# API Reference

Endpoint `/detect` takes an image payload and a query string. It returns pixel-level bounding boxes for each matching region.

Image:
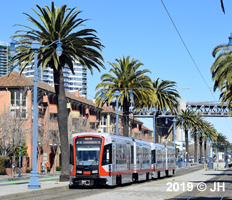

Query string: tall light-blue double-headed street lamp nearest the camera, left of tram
[9,39,63,189]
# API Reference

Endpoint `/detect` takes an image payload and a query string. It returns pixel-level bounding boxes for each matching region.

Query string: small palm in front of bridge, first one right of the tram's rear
[176,109,195,160]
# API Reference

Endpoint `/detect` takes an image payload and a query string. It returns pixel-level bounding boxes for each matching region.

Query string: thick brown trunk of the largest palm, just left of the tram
[53,66,69,181]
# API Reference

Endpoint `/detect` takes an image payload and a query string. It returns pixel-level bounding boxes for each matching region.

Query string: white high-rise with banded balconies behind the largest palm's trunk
[22,62,87,96]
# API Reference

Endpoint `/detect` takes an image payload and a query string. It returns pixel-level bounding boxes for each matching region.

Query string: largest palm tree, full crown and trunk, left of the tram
[10,2,104,181]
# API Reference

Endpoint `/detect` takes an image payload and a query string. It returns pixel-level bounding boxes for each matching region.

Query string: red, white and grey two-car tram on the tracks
[69,132,175,188]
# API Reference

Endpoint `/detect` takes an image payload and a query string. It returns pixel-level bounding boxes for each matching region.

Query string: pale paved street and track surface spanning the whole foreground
[0,165,232,200]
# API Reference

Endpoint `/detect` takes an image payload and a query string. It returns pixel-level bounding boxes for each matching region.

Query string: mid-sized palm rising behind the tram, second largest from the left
[95,56,153,136]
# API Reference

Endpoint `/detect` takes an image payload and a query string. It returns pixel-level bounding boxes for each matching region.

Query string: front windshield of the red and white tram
[76,145,101,166]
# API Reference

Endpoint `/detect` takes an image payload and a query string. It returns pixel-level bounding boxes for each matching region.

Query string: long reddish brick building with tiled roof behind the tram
[0,72,152,173]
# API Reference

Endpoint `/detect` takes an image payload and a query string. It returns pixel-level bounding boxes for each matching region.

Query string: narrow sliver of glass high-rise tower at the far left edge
[0,41,9,77]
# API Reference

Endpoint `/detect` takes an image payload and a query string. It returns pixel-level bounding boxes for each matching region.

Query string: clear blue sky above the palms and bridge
[0,0,232,142]
